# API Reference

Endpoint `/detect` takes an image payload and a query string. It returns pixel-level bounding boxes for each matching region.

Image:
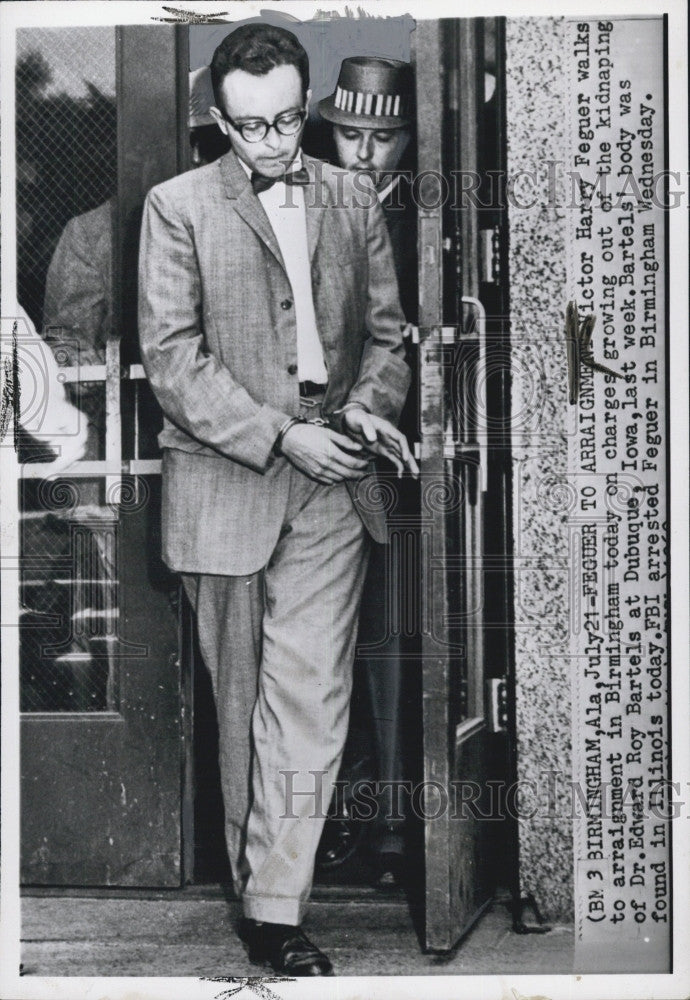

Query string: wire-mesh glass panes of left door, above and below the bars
[16,27,118,712]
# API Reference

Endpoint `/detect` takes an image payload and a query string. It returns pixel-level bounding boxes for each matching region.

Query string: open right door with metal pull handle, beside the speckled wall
[416,18,517,952]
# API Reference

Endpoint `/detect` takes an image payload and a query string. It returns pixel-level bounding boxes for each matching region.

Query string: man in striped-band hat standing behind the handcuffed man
[317,56,420,886]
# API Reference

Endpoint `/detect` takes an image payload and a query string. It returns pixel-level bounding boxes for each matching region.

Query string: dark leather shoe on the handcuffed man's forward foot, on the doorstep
[237,917,333,976]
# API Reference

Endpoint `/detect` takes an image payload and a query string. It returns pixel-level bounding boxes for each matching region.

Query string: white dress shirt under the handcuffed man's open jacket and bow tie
[238,157,328,385]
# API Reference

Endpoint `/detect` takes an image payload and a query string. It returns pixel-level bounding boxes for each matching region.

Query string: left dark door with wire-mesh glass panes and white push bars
[17,27,183,886]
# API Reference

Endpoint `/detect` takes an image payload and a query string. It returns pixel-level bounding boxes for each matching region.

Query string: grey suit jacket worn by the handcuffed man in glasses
[139,152,410,575]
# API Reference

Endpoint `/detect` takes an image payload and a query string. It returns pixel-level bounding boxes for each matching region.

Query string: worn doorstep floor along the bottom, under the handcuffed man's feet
[21,886,574,977]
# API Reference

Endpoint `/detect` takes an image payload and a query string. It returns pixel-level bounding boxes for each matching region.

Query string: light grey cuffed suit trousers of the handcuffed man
[183,414,369,924]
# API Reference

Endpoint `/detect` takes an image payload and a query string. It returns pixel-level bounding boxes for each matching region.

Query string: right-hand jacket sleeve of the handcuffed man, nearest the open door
[341,186,411,424]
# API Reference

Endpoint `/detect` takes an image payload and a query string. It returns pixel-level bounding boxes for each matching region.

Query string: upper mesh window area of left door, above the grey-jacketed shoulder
[16,28,117,328]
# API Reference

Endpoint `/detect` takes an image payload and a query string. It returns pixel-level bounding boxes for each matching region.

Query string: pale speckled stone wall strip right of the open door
[506,18,573,921]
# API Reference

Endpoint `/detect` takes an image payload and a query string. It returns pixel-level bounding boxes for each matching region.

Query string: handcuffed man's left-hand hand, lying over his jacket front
[280,424,369,483]
